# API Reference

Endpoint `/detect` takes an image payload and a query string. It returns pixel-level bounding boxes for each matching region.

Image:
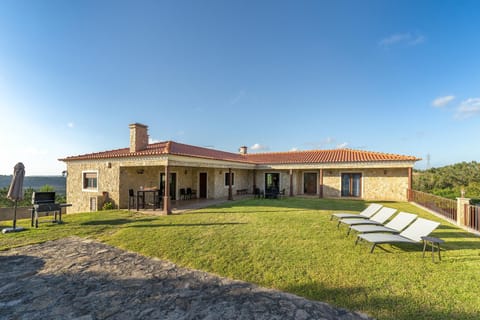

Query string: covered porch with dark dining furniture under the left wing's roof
[118,159,253,214]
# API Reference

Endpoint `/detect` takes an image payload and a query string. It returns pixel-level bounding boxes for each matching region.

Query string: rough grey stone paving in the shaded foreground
[0,237,369,320]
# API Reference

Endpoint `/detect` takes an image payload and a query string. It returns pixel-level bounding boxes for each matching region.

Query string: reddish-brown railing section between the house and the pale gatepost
[408,189,458,221]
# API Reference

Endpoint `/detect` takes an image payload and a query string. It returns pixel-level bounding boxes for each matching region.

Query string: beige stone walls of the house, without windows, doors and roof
[67,158,408,212]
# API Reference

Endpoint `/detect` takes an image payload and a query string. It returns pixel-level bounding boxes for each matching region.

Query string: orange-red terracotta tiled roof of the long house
[60,141,420,164]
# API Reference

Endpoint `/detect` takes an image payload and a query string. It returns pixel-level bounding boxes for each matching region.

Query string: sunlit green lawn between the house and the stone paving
[0,198,480,319]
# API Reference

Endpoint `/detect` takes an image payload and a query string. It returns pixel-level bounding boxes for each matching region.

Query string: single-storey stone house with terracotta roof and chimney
[60,123,420,214]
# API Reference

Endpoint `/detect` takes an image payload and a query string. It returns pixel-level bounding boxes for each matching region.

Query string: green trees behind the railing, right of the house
[412,161,480,202]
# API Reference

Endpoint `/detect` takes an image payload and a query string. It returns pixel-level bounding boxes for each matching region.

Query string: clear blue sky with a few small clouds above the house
[0,0,480,175]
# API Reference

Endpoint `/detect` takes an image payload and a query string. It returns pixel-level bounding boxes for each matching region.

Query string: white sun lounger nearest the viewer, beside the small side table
[356,218,440,253]
